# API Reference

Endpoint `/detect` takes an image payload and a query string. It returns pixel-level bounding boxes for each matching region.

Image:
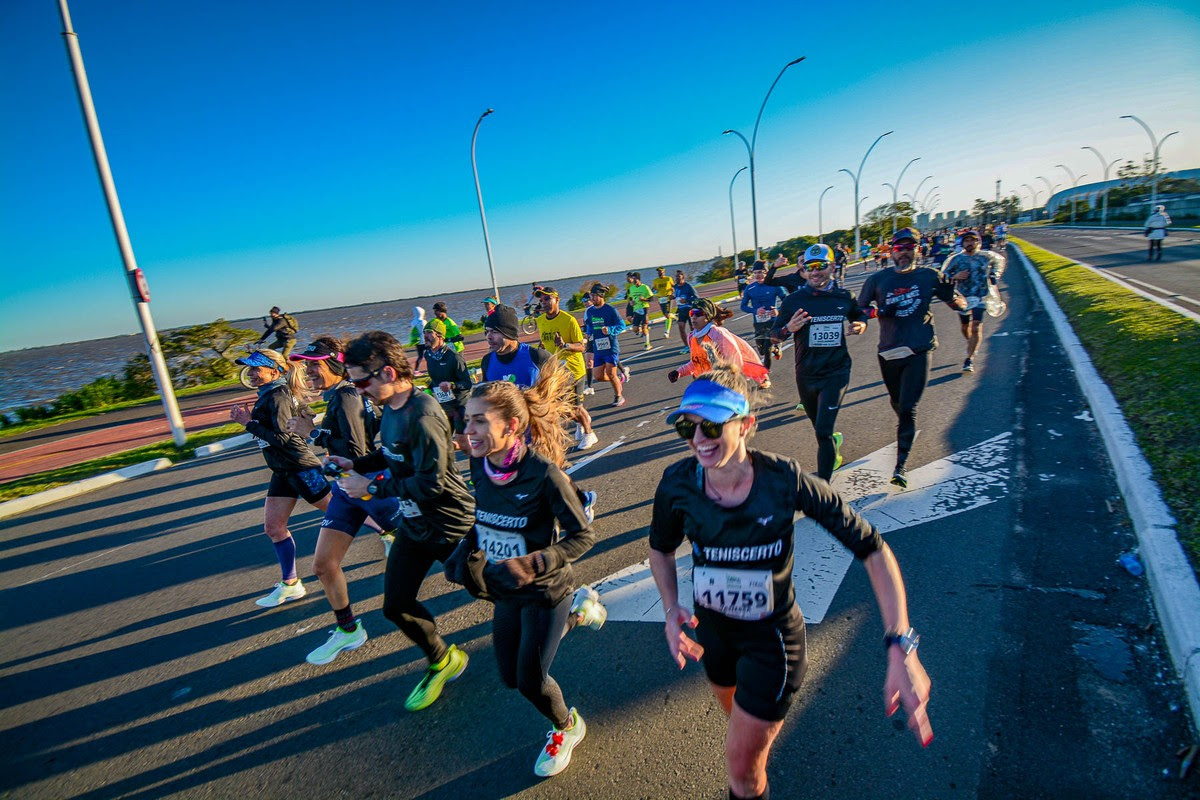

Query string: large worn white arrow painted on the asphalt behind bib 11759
[594,432,1012,625]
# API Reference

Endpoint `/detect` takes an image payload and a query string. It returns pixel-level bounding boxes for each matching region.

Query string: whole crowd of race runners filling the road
[232,228,1003,798]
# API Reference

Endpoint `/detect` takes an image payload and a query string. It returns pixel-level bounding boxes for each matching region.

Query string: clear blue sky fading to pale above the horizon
[0,0,1200,349]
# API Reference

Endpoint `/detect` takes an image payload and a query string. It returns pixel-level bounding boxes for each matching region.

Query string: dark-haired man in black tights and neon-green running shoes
[328,331,477,711]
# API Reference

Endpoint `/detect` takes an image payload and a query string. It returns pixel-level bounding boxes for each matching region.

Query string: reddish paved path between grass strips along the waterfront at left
[0,279,733,483]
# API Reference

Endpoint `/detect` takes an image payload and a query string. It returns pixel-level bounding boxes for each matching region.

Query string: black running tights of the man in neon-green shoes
[383,533,455,663]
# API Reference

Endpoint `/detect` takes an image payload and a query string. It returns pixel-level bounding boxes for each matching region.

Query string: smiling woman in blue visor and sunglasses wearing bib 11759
[649,366,934,798]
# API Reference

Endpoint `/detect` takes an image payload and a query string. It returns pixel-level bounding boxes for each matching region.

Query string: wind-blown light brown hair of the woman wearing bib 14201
[470,359,575,467]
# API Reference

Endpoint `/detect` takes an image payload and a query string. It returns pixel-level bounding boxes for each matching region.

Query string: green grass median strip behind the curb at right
[1010,237,1200,573]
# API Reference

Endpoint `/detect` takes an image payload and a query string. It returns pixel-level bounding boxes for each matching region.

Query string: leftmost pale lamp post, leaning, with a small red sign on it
[59,0,187,447]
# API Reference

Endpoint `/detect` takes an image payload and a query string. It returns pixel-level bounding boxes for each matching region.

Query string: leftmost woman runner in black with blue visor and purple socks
[229,350,329,608]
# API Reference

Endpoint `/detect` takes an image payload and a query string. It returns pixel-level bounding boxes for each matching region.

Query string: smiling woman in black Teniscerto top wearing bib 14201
[446,369,607,777]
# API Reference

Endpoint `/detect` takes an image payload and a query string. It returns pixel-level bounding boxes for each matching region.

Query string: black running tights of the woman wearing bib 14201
[492,595,571,729]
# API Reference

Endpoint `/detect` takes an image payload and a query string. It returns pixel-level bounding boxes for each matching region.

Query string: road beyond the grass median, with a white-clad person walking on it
[1013,227,1200,312]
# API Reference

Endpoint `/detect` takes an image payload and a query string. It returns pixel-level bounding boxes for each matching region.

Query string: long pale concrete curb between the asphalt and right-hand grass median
[1013,239,1200,727]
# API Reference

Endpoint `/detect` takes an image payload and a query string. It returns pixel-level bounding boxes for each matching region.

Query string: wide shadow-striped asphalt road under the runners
[0,257,1200,800]
